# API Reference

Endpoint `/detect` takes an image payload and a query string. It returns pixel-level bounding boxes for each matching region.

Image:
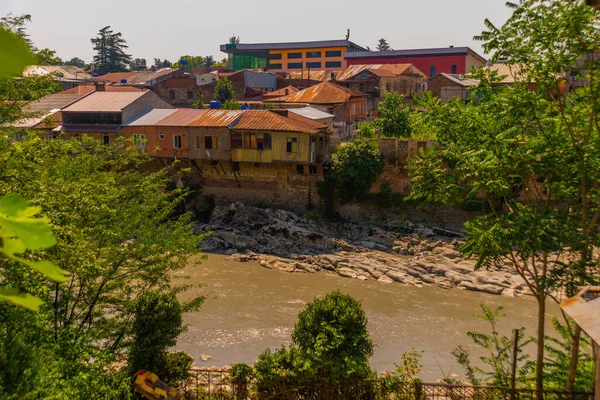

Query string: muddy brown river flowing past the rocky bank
[176,254,558,381]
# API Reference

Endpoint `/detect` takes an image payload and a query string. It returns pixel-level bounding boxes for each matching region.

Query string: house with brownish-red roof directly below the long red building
[336,64,427,111]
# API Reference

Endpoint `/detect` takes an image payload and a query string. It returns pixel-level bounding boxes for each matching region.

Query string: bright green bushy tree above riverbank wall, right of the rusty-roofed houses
[375,91,411,138]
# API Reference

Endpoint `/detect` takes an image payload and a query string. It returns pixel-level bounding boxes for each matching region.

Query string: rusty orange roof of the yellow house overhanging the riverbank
[234,110,327,133]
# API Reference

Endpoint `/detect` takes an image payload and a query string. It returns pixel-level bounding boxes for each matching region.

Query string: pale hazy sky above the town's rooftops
[0,0,510,64]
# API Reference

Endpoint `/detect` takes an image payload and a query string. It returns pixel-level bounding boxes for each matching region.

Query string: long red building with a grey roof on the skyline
[346,46,486,77]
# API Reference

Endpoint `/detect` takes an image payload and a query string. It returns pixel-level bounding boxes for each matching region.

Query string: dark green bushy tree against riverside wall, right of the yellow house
[326,139,383,203]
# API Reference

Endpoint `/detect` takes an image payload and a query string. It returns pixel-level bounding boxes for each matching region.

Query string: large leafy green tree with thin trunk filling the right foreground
[410,0,600,392]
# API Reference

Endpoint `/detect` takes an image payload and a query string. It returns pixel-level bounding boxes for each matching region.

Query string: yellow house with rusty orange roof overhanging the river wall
[231,110,329,169]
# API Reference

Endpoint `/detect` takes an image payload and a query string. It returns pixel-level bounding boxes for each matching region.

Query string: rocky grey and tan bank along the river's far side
[196,203,529,297]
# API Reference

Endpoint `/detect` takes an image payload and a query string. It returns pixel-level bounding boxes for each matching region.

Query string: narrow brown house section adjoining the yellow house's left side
[188,110,245,163]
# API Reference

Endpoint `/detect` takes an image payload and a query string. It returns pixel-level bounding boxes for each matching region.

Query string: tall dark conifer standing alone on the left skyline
[90,26,132,75]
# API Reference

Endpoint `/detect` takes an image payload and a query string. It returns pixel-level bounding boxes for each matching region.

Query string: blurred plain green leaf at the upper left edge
[0,28,35,78]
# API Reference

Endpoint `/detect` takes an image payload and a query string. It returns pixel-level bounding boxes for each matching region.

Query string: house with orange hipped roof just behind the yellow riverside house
[285,82,369,137]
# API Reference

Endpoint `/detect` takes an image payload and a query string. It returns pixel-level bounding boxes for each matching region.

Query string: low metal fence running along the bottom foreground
[180,368,594,400]
